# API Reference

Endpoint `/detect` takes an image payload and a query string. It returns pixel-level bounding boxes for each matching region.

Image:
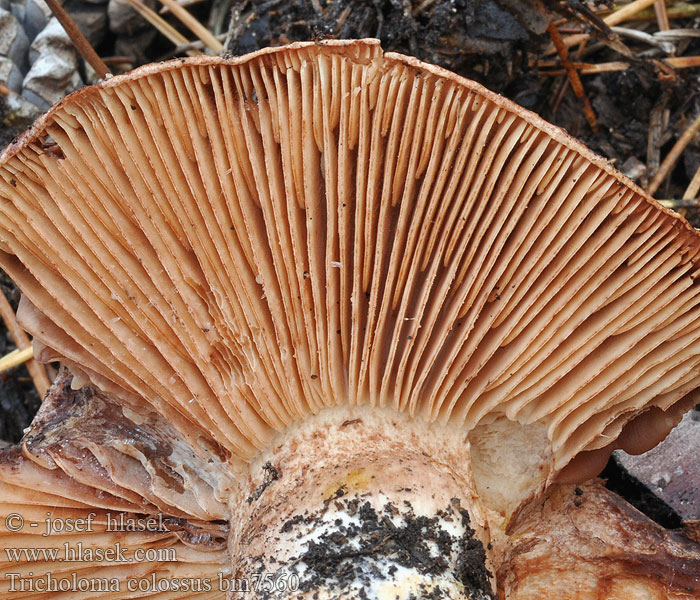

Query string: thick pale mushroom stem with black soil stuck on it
[229,406,493,599]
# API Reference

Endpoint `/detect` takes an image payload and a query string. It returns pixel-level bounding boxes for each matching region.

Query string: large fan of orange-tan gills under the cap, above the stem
[0,40,700,478]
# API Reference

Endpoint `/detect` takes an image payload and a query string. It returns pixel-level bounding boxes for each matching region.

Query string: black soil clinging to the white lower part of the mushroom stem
[274,488,493,600]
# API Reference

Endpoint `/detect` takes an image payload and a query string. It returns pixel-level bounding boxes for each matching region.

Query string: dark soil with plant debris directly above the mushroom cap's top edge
[227,0,549,92]
